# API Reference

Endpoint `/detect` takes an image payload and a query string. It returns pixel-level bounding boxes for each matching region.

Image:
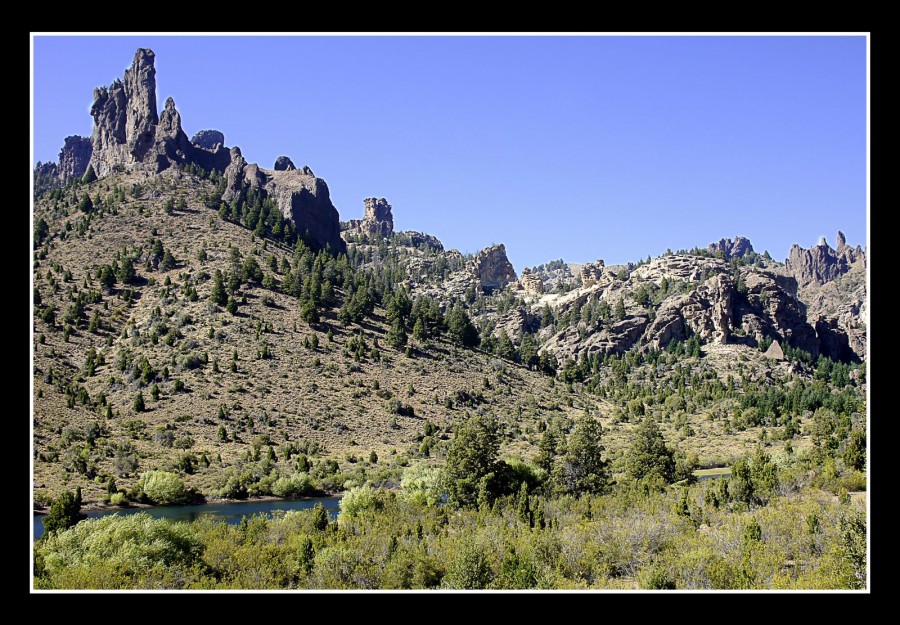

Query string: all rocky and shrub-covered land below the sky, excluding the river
[32,49,867,590]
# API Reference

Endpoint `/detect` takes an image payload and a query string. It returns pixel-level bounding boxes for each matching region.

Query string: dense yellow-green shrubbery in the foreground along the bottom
[36,456,865,589]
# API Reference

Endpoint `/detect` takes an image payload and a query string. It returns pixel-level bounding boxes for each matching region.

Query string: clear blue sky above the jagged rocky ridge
[33,36,866,271]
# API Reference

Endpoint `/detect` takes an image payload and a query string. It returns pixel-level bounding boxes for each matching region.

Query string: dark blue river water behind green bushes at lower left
[33,497,340,540]
